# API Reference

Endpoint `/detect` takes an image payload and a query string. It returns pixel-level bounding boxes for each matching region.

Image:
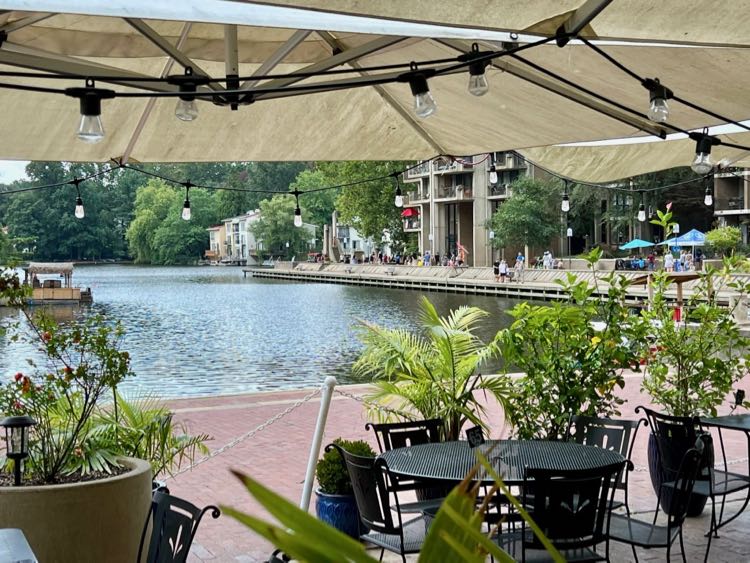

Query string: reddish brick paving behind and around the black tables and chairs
[167,373,750,563]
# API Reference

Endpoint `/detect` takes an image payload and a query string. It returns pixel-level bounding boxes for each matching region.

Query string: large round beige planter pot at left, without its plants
[0,458,151,563]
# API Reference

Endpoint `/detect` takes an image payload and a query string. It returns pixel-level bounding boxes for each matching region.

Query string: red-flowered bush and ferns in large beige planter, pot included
[0,272,209,562]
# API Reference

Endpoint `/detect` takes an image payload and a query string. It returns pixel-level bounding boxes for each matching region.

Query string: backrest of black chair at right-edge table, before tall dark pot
[635,406,714,481]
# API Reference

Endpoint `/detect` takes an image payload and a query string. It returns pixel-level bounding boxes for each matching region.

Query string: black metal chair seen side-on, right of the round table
[609,446,711,563]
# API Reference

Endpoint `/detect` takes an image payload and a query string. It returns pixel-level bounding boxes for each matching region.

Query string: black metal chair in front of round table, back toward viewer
[498,461,627,562]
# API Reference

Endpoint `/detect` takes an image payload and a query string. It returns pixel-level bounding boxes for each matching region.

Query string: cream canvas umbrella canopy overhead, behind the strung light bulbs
[0,0,750,180]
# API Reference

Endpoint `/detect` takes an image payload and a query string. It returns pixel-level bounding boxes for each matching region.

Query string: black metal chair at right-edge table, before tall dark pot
[635,406,750,558]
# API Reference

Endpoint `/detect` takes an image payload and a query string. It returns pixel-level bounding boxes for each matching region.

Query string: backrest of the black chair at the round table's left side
[326,444,401,534]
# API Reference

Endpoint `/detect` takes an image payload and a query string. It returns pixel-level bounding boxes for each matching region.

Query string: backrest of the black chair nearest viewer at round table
[523,461,627,550]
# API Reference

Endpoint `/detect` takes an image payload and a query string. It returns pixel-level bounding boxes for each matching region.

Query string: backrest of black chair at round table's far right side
[567,415,645,490]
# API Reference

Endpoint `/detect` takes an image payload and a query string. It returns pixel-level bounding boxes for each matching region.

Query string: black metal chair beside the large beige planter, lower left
[138,491,221,563]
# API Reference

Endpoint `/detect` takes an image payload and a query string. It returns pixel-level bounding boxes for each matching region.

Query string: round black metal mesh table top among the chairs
[380,440,625,484]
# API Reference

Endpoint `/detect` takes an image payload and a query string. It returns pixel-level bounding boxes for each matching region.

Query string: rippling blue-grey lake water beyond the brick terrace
[0,265,517,397]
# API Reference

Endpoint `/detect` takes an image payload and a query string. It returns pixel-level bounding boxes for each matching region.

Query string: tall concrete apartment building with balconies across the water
[401,152,540,266]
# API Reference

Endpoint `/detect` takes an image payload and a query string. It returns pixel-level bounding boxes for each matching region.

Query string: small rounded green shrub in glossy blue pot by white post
[315,438,375,538]
